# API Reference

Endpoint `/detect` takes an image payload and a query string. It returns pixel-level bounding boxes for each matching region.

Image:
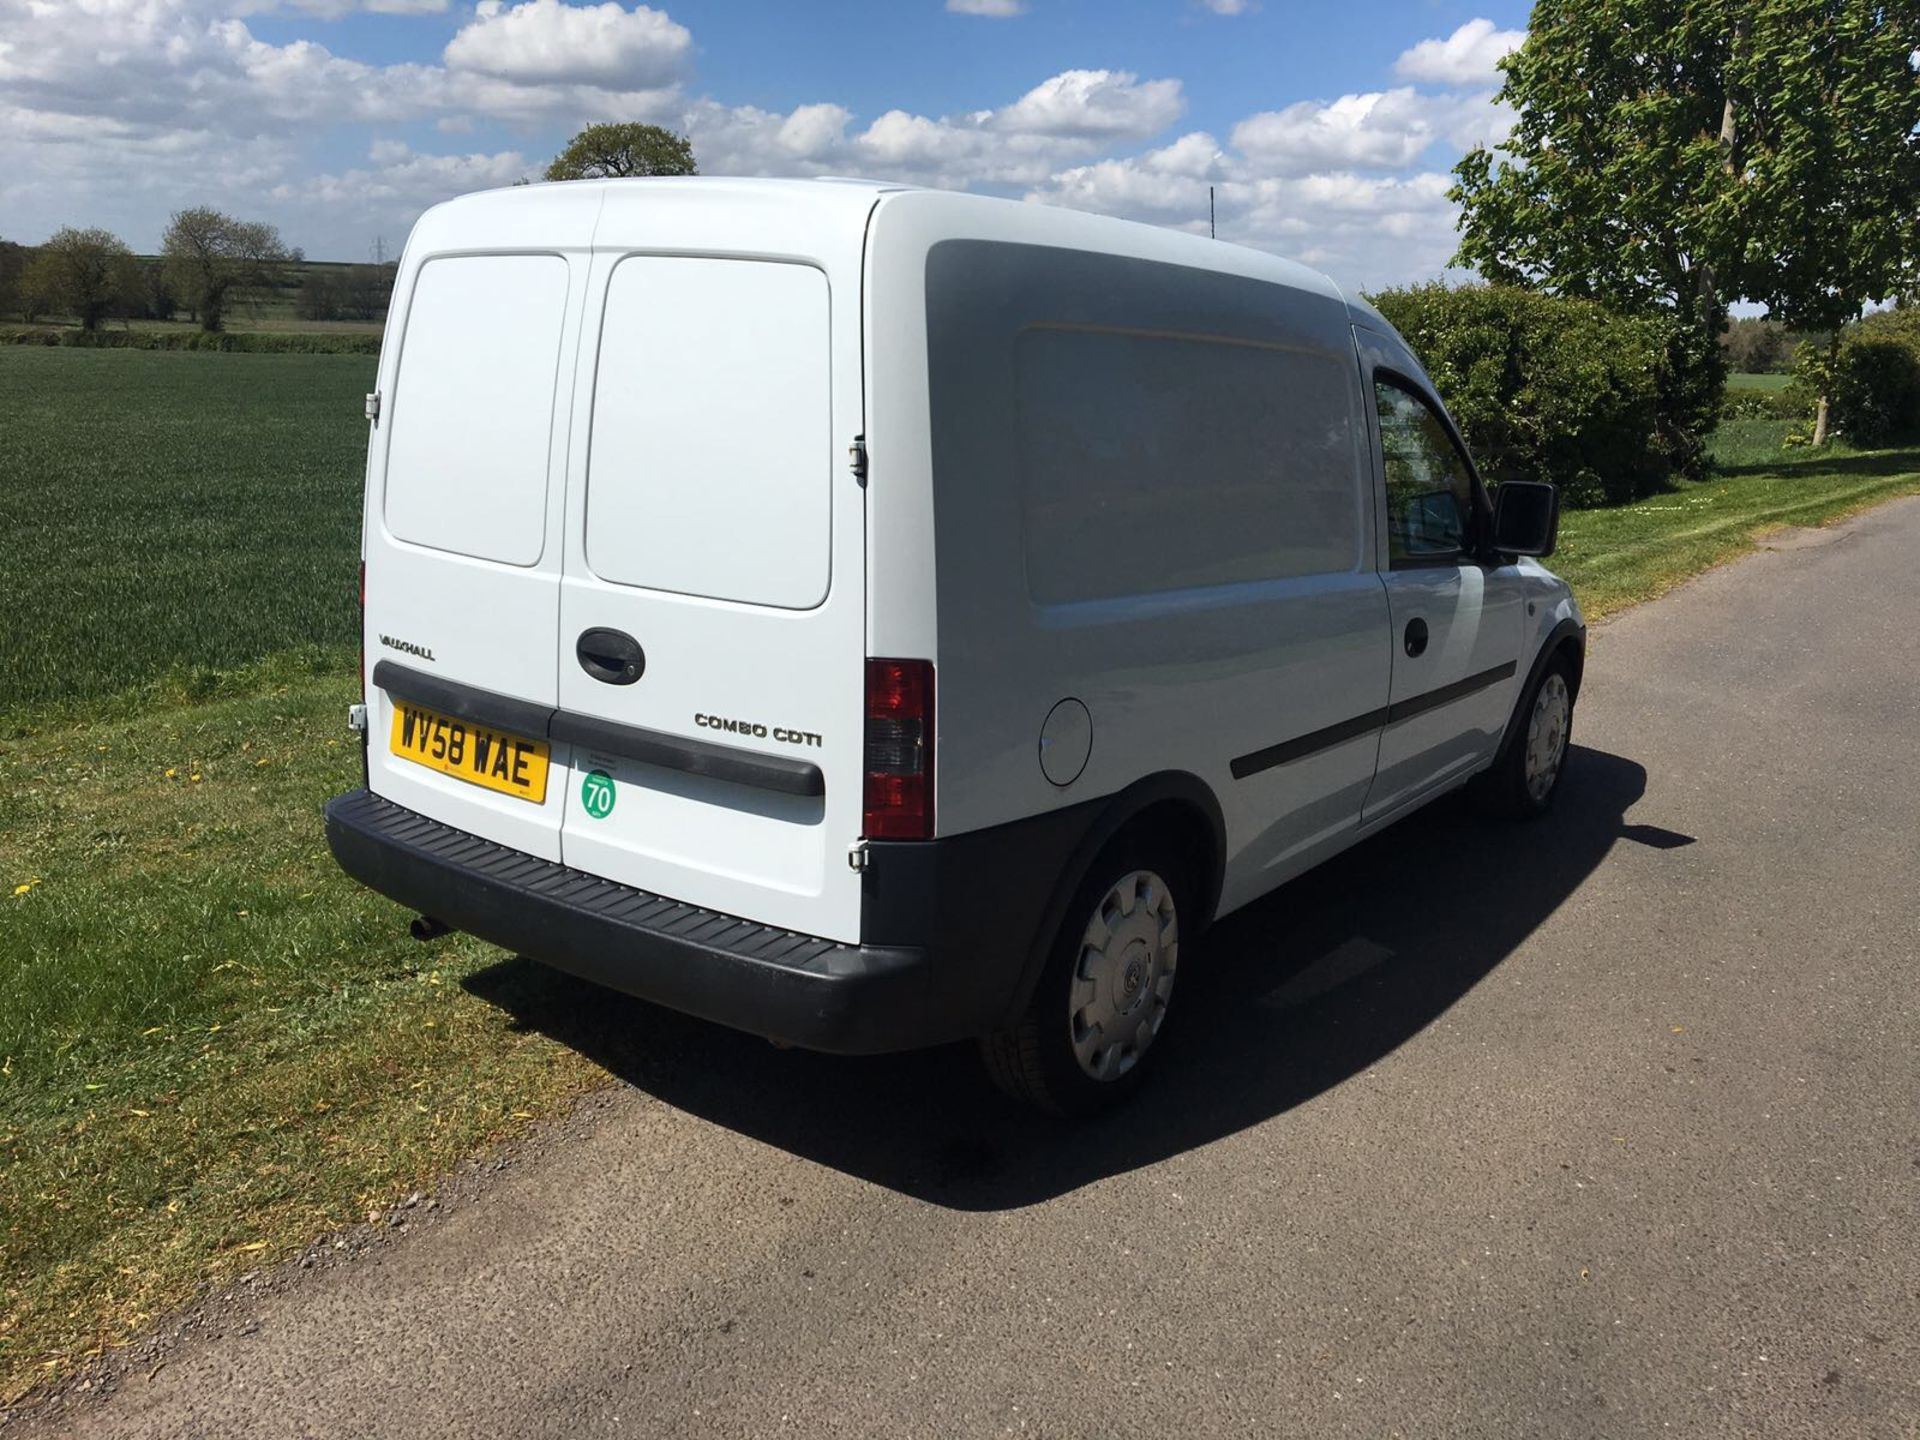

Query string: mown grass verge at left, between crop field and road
[0,674,599,1404]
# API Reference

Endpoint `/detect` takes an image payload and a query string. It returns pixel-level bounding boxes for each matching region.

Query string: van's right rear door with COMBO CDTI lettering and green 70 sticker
[555,184,870,941]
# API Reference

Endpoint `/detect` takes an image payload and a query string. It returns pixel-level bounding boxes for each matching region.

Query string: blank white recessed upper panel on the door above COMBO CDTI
[586,255,833,611]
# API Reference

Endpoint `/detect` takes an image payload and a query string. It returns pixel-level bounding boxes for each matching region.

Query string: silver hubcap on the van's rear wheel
[1068,870,1181,1081]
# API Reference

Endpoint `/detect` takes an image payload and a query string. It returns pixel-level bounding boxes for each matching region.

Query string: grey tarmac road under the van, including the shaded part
[25,499,1920,1440]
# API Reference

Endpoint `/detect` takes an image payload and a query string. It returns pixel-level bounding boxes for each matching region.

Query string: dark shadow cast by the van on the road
[467,747,1666,1210]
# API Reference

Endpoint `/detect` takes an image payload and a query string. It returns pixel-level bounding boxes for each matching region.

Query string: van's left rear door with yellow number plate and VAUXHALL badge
[363,188,599,860]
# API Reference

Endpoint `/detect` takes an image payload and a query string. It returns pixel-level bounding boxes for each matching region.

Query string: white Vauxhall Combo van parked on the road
[326,179,1586,1112]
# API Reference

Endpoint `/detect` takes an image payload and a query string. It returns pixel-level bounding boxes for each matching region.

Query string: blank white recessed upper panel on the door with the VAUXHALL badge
[382,255,566,564]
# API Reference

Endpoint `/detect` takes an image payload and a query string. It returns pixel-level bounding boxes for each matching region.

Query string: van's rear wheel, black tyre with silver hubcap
[981,837,1194,1117]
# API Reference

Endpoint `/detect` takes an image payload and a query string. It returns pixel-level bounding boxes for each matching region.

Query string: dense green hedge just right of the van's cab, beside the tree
[1369,282,1697,505]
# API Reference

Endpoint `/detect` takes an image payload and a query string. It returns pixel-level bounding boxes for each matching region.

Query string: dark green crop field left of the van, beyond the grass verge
[0,348,374,733]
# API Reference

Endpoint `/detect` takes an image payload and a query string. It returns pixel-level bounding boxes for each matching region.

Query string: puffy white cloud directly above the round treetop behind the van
[445,0,693,90]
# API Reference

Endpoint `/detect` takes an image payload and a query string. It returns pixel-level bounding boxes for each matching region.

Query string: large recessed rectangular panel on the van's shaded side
[1014,323,1361,605]
